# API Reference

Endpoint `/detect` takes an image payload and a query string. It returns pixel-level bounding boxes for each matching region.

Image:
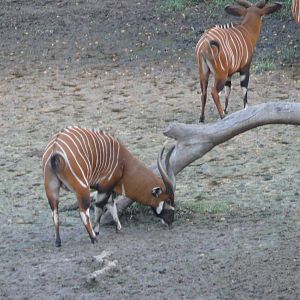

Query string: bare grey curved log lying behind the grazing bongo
[101,102,300,225]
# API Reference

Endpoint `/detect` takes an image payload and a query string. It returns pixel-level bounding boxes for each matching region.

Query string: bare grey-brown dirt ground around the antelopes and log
[0,0,300,299]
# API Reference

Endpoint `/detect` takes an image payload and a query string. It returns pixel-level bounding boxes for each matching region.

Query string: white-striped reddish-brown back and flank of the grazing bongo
[42,127,120,188]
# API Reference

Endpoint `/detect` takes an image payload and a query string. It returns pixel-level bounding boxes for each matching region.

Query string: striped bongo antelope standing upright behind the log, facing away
[195,0,281,122]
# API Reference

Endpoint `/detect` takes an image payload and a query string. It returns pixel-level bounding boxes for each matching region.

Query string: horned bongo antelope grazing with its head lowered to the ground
[42,127,175,247]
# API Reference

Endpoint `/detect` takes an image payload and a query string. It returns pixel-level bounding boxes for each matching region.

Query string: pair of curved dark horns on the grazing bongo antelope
[157,146,175,198]
